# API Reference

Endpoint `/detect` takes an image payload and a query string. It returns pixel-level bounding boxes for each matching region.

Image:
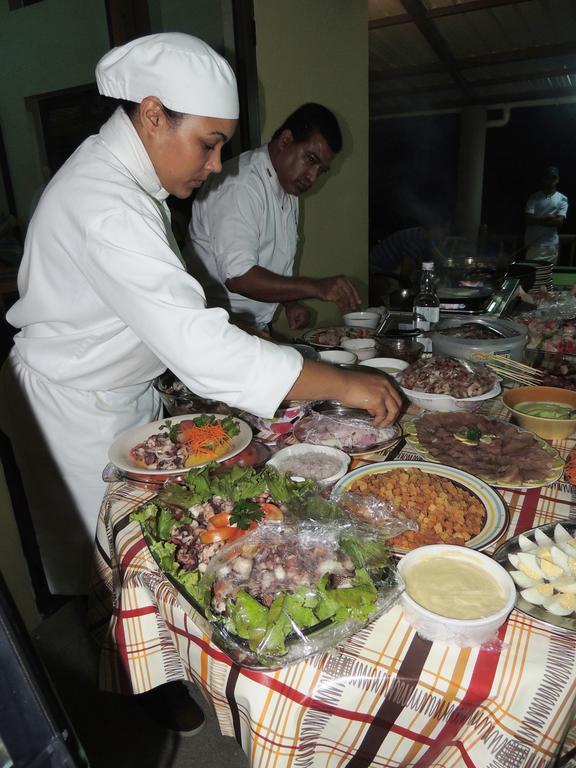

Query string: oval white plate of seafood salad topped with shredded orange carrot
[108,413,252,477]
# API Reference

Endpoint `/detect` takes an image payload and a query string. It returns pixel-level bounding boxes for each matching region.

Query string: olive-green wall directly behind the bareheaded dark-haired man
[254,0,368,333]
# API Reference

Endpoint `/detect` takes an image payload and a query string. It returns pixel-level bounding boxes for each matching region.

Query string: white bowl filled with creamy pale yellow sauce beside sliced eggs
[398,544,516,647]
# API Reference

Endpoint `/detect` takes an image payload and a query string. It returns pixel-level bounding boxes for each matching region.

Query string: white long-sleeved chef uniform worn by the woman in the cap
[0,110,302,593]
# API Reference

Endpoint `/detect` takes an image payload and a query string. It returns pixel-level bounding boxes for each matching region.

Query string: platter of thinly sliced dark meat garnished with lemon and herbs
[404,413,564,488]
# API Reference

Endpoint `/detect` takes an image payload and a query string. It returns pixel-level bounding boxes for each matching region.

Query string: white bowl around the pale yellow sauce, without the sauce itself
[398,544,516,648]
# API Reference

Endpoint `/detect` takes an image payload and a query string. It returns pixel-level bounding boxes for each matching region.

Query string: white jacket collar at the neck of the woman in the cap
[100,107,170,202]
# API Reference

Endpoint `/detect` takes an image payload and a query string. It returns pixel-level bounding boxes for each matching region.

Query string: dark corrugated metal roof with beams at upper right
[368,0,576,117]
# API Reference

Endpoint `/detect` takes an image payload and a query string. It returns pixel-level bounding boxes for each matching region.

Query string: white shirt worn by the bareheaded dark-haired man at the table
[184,145,298,327]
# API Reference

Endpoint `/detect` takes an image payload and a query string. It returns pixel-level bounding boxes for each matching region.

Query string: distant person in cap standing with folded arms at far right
[524,165,568,264]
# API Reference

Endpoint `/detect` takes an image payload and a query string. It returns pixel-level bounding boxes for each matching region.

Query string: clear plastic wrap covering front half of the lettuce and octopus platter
[203,521,403,669]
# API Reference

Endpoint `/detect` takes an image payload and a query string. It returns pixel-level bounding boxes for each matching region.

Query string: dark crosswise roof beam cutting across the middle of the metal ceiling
[370,40,576,82]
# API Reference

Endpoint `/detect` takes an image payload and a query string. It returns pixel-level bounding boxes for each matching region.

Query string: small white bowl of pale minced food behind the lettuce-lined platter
[267,443,350,486]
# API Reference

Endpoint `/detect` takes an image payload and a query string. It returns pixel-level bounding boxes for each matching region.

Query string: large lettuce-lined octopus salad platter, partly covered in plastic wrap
[130,465,402,669]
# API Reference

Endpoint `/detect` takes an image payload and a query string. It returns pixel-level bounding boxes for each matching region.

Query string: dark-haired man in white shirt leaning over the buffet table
[184,103,361,330]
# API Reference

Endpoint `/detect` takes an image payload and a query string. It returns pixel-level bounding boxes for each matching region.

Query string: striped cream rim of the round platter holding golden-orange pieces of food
[333,461,509,554]
